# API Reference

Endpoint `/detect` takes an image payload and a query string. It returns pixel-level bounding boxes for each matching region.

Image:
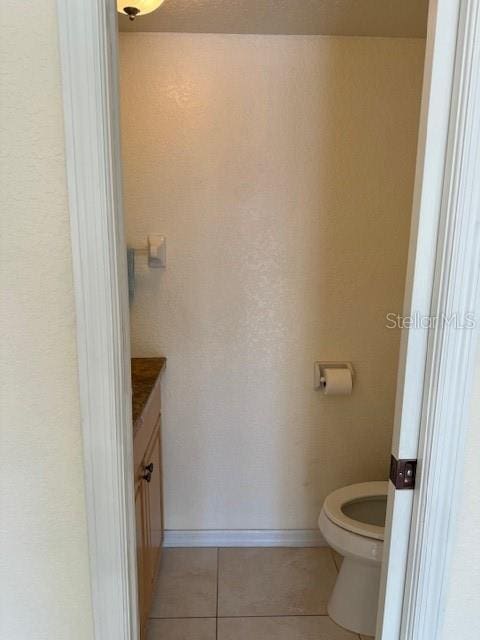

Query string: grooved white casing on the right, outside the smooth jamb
[401,0,480,640]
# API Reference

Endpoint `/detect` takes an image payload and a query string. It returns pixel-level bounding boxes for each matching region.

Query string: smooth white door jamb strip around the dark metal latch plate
[377,0,461,640]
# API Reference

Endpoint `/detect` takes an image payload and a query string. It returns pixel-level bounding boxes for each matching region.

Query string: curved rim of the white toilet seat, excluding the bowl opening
[323,482,388,540]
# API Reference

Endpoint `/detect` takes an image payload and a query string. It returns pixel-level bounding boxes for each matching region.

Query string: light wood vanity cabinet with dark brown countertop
[132,358,166,640]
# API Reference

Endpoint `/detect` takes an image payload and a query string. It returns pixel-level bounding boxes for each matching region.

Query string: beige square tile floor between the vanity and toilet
[148,548,376,640]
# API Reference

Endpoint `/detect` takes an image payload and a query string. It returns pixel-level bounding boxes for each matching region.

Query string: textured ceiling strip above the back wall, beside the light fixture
[119,0,428,38]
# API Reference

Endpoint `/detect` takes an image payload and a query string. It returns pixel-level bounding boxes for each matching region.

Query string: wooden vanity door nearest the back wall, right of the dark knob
[144,418,163,602]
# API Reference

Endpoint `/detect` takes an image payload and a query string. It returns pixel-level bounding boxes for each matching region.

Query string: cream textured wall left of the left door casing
[0,0,93,640]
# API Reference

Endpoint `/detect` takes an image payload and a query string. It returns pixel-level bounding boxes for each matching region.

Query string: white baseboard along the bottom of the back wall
[164,529,327,547]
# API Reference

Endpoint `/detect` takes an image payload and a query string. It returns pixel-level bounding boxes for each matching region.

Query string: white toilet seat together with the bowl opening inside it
[323,482,388,540]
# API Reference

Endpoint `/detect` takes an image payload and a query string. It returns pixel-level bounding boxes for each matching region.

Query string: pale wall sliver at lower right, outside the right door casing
[442,332,480,640]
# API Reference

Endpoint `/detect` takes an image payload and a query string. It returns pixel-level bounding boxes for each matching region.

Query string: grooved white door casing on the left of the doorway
[57,0,138,640]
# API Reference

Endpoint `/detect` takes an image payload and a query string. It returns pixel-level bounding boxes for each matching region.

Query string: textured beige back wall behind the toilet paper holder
[120,34,424,529]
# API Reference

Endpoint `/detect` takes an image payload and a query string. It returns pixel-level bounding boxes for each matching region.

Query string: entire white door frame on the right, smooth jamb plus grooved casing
[376,0,480,640]
